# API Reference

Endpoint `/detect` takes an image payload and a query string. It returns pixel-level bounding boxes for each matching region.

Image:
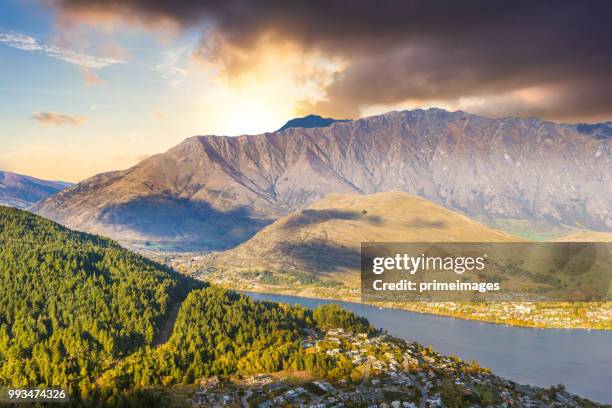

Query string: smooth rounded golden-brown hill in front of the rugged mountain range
[210,192,520,280]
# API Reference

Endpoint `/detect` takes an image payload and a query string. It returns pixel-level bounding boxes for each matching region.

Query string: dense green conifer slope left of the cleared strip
[0,207,194,393]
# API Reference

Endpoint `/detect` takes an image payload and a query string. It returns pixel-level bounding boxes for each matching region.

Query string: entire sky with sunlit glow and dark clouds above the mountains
[0,0,612,181]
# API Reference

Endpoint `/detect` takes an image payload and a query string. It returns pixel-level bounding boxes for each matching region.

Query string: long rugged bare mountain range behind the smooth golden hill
[34,109,612,248]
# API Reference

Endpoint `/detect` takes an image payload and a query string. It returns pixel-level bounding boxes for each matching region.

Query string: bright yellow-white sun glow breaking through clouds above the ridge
[189,39,346,135]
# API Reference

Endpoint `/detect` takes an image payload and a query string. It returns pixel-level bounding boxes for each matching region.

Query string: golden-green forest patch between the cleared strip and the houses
[100,287,372,403]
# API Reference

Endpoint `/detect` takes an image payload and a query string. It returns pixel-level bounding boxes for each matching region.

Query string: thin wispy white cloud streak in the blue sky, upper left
[0,33,123,68]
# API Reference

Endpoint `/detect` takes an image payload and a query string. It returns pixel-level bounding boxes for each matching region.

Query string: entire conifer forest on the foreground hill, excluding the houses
[0,207,372,406]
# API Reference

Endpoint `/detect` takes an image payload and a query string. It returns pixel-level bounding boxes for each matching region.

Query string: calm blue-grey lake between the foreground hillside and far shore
[243,292,612,403]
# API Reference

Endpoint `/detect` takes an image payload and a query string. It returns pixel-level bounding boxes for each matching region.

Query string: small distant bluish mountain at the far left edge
[0,171,72,208]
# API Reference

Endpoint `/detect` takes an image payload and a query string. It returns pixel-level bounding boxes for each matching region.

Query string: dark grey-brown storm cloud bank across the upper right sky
[51,0,612,120]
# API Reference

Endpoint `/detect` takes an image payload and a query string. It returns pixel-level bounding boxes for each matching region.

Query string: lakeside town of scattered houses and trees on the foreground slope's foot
[183,329,599,408]
